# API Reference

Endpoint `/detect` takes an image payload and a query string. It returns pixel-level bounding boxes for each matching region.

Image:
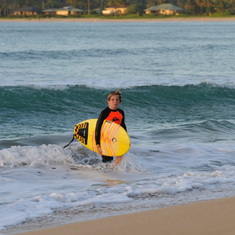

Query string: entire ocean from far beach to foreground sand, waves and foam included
[0,22,235,234]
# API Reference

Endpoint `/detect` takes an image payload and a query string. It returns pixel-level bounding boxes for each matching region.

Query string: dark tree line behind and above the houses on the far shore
[0,0,235,16]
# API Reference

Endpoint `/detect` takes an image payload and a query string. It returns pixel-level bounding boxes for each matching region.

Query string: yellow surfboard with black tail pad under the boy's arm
[74,119,131,157]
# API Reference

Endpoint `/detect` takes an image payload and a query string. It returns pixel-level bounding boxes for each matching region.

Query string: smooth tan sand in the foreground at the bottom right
[13,198,235,235]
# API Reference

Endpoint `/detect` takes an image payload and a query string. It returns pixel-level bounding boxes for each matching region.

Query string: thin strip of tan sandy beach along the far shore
[0,16,235,23]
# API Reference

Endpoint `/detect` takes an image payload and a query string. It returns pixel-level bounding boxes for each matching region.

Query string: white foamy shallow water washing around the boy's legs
[0,140,235,229]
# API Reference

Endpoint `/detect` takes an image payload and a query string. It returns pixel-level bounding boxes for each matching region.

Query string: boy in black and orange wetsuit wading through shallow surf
[95,90,127,164]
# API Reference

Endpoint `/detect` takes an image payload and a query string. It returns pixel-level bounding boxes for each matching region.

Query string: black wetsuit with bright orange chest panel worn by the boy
[95,107,127,162]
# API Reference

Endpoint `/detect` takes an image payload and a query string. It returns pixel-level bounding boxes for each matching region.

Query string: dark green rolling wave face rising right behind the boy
[0,83,235,119]
